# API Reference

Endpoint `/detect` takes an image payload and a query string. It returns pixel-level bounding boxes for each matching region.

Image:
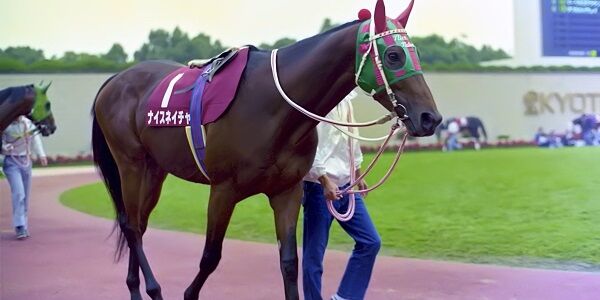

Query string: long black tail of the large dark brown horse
[92,74,127,261]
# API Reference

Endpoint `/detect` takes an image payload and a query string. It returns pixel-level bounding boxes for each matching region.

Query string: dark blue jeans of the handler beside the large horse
[302,181,381,300]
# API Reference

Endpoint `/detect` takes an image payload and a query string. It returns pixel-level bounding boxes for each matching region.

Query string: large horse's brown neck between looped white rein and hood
[278,23,359,116]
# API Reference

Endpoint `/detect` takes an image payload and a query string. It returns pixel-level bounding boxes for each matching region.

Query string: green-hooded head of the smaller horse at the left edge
[27,82,56,136]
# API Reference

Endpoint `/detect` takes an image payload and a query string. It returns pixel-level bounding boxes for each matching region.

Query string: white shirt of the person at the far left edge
[2,116,46,157]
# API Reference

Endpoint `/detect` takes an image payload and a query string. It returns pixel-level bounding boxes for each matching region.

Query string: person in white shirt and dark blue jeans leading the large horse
[302,92,381,300]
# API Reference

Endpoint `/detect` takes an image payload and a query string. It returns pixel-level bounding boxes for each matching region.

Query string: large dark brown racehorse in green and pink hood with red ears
[92,0,441,300]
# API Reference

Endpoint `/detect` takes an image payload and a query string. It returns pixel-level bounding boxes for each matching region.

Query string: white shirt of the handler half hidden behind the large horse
[304,91,363,186]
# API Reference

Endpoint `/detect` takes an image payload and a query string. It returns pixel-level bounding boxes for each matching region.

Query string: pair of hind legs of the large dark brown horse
[120,161,166,300]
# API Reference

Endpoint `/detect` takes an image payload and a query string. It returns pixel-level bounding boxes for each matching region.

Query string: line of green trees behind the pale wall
[0,18,600,73]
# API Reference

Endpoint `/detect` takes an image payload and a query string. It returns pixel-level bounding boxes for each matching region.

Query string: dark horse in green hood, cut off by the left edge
[0,82,56,146]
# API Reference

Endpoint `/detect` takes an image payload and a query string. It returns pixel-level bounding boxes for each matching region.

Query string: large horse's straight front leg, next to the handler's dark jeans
[269,184,302,300]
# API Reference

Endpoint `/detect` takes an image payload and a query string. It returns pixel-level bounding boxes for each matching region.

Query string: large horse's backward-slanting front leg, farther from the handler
[183,184,240,300]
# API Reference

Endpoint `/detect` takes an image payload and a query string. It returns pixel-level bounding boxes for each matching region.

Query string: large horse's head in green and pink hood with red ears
[356,0,442,136]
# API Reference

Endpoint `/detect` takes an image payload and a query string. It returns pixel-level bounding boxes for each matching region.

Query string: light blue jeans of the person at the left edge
[2,156,31,229]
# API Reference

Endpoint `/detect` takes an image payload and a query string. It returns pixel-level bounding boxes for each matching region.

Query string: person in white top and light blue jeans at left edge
[2,116,48,239]
